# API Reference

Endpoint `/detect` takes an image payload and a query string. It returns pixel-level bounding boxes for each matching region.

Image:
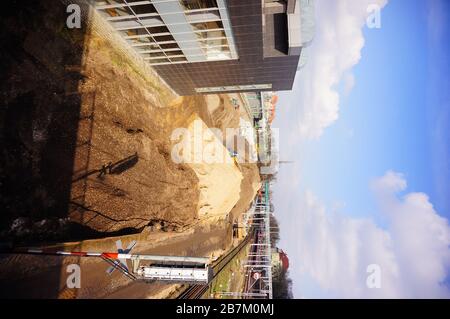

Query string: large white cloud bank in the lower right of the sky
[286,172,450,298]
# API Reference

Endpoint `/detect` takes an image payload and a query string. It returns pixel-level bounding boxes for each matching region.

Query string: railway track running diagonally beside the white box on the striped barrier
[177,231,254,299]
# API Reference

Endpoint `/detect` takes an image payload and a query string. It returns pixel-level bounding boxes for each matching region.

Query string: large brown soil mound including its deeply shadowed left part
[0,1,210,241]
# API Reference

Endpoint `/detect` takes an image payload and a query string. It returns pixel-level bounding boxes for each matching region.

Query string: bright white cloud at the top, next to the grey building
[289,0,387,138]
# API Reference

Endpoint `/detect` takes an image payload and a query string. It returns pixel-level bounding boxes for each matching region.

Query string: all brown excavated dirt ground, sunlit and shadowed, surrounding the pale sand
[0,0,259,298]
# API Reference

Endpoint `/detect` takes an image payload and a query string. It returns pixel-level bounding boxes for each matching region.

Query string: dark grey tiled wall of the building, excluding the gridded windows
[154,0,299,95]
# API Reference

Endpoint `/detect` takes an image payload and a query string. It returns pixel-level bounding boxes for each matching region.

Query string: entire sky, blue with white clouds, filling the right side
[274,0,450,298]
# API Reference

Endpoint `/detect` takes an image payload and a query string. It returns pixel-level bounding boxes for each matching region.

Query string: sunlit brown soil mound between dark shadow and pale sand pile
[69,31,207,232]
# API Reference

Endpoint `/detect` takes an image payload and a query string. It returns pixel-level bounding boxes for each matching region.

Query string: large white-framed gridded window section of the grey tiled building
[95,0,238,65]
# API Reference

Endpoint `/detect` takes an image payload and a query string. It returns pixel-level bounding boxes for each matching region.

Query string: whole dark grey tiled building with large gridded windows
[94,0,309,95]
